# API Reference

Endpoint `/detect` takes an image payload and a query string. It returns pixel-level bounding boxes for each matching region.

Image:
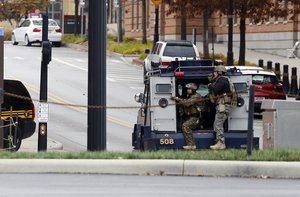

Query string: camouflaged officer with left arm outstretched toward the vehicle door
[171,83,202,150]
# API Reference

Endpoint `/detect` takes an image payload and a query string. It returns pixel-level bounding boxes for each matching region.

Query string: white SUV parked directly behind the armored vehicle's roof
[144,40,200,75]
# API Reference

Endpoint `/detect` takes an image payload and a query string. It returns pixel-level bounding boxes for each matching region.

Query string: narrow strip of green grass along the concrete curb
[0,149,300,161]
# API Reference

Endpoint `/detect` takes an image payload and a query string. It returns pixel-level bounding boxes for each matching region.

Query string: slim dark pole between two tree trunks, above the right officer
[227,0,233,66]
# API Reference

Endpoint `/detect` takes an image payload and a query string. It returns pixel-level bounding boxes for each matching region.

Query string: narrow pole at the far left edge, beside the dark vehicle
[0,28,4,149]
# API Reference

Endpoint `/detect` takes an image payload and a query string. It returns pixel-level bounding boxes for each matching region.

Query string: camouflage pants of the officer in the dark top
[214,104,230,143]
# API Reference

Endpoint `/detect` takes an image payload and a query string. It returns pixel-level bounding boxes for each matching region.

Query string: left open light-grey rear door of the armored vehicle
[150,76,177,133]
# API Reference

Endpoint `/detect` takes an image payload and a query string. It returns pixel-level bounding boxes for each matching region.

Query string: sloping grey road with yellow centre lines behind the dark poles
[4,44,143,151]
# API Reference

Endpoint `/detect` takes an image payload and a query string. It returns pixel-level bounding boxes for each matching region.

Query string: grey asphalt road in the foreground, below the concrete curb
[0,174,300,197]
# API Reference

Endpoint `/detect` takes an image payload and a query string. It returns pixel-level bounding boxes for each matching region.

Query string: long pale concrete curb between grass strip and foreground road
[0,159,300,179]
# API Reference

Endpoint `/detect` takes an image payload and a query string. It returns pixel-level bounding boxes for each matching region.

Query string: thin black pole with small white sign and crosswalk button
[38,11,52,151]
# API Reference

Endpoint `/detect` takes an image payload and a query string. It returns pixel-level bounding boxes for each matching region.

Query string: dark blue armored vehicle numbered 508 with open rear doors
[132,60,258,150]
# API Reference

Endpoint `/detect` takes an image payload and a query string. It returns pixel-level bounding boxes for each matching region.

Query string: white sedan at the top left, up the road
[11,18,62,46]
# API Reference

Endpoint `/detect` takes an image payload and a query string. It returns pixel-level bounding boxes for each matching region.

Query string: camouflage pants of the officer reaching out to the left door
[182,117,199,146]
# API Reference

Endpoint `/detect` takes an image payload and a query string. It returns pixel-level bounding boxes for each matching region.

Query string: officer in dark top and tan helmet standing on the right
[208,66,231,150]
